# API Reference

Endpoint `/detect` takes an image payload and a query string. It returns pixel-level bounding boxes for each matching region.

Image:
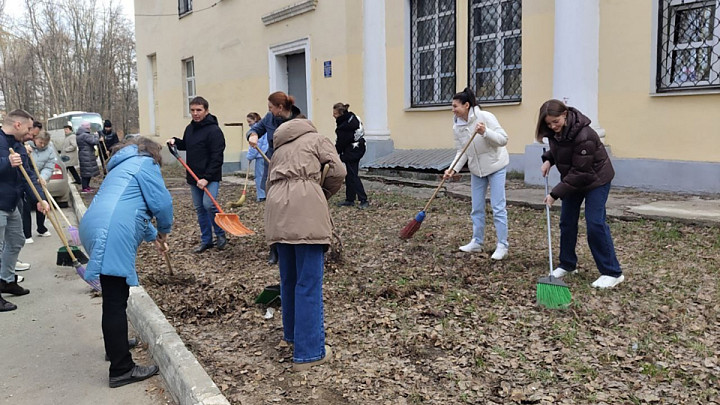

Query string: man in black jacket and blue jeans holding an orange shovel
[167,97,227,253]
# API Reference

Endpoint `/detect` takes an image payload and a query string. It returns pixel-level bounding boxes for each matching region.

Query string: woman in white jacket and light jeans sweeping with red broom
[445,88,510,260]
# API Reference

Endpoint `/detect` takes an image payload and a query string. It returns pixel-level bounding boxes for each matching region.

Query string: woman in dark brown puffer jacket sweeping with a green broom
[536,100,625,289]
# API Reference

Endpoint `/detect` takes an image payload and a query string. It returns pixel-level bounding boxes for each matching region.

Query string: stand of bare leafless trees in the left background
[0,0,138,133]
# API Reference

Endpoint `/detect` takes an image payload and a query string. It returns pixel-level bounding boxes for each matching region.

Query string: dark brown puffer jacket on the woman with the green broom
[542,107,615,199]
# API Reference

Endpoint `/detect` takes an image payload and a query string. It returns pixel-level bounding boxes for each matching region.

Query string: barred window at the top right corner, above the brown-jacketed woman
[656,0,720,92]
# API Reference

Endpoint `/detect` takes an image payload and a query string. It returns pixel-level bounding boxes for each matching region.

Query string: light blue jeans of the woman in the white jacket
[470,168,509,248]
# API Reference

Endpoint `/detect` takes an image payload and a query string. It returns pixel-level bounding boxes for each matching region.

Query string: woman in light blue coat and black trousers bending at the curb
[80,137,173,388]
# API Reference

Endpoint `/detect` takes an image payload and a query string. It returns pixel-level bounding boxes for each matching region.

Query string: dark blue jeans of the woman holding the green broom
[560,183,622,277]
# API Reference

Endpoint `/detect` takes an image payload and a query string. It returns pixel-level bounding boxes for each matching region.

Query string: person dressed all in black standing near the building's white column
[333,103,370,209]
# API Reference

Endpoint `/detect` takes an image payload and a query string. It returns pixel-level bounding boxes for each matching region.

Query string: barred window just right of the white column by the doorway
[410,0,456,107]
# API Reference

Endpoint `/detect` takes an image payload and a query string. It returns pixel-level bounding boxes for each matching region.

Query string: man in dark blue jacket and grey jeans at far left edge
[0,110,50,312]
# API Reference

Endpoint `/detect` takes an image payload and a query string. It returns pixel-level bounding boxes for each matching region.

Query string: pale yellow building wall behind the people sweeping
[135,0,720,191]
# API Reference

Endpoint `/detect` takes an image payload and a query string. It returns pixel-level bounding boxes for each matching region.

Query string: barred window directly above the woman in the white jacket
[468,0,522,102]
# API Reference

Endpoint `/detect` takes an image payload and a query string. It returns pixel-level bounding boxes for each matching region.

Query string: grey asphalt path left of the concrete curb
[0,209,169,405]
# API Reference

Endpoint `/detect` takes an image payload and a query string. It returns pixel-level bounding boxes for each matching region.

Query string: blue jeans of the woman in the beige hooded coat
[275,243,325,363]
